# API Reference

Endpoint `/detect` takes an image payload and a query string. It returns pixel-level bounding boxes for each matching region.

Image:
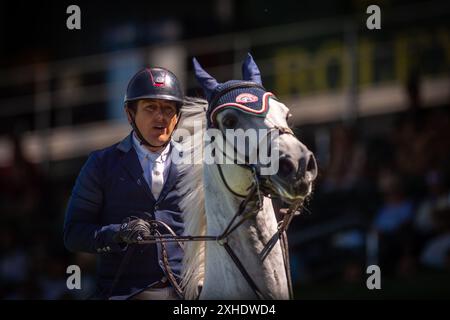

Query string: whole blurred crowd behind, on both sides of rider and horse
[0,84,450,299]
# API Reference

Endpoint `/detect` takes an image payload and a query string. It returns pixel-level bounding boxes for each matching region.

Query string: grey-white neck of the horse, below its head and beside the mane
[201,165,289,299]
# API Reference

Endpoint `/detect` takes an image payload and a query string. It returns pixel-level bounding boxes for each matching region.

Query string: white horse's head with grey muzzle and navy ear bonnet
[194,54,317,203]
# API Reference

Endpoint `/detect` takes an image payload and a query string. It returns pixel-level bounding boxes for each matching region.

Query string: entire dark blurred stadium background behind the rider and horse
[0,0,450,299]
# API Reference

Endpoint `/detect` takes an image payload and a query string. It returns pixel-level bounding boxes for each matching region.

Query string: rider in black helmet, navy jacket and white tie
[64,68,184,299]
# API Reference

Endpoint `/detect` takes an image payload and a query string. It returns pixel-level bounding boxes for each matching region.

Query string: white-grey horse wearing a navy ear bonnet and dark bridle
[174,54,317,300]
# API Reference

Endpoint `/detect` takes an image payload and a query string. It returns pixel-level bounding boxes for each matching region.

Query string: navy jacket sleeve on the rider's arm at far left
[64,153,123,253]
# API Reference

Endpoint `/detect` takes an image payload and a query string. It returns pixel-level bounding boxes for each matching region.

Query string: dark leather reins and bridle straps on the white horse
[109,84,303,299]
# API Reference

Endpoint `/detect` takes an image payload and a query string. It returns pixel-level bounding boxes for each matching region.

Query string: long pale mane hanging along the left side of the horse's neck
[178,97,208,299]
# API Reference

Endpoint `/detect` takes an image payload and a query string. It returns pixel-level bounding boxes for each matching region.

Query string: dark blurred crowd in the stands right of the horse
[290,95,450,282]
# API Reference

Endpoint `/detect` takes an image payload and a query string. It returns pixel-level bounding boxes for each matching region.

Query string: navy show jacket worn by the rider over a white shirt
[64,133,184,296]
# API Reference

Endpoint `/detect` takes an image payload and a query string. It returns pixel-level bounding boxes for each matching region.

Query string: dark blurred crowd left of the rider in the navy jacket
[0,134,93,299]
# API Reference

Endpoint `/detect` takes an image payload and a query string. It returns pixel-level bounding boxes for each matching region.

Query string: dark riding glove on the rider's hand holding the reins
[115,217,151,244]
